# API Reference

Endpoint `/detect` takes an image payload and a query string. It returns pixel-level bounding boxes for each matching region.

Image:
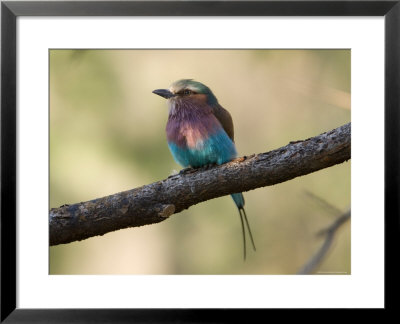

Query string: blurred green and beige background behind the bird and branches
[49,50,351,274]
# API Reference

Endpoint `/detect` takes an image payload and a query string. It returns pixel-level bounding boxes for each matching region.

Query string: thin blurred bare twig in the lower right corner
[297,210,351,274]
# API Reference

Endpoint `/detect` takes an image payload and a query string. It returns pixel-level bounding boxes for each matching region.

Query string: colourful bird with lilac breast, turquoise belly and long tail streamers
[153,79,256,260]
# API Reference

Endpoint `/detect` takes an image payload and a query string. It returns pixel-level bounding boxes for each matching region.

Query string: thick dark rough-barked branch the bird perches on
[49,123,351,245]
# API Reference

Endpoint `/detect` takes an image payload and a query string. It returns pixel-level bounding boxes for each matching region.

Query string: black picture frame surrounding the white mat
[1,0,400,323]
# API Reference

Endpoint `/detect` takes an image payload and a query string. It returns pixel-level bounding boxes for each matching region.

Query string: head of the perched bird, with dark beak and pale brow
[153,79,218,105]
